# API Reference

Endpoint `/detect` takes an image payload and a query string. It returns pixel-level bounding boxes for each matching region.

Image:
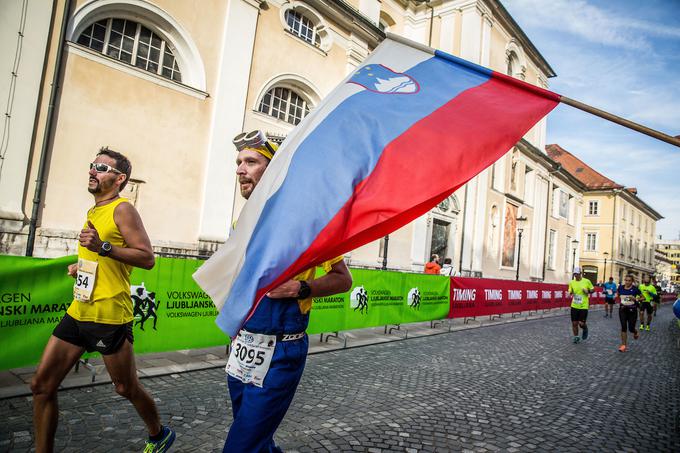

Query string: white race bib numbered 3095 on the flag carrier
[225,330,276,387]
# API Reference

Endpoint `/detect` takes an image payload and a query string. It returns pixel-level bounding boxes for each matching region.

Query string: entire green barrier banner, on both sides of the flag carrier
[0,255,450,370]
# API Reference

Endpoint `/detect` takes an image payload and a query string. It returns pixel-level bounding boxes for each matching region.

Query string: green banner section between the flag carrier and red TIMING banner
[307,269,450,334]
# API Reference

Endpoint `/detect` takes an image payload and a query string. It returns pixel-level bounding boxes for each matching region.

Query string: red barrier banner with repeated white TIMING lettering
[449,277,571,318]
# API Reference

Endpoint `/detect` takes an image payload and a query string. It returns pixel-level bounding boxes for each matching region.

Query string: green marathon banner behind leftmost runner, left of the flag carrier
[0,255,228,370]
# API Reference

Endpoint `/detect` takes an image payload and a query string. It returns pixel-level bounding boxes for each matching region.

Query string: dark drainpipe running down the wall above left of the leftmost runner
[26,0,71,256]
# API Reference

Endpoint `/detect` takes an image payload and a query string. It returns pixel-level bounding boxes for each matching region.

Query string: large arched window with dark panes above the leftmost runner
[78,18,182,82]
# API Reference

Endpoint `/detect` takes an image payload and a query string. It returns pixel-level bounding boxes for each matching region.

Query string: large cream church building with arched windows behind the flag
[0,0,583,281]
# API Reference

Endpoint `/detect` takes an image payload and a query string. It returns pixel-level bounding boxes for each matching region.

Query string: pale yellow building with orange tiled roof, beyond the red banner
[546,145,663,282]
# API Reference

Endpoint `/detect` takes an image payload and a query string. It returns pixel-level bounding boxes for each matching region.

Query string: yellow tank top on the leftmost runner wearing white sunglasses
[67,198,133,324]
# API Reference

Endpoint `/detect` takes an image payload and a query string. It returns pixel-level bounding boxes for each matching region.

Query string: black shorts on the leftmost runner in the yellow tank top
[52,313,134,355]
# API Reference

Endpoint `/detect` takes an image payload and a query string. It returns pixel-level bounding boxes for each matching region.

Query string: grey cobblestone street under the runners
[0,305,680,452]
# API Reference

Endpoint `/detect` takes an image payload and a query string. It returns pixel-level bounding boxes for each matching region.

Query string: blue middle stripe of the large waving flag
[216,53,489,333]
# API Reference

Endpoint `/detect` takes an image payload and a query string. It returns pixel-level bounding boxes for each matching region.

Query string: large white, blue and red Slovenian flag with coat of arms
[194,33,559,336]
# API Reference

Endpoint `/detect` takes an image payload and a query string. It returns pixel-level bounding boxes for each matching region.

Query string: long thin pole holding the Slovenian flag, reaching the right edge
[385,32,680,147]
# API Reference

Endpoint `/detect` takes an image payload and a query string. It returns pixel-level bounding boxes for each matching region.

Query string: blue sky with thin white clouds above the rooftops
[501,0,680,239]
